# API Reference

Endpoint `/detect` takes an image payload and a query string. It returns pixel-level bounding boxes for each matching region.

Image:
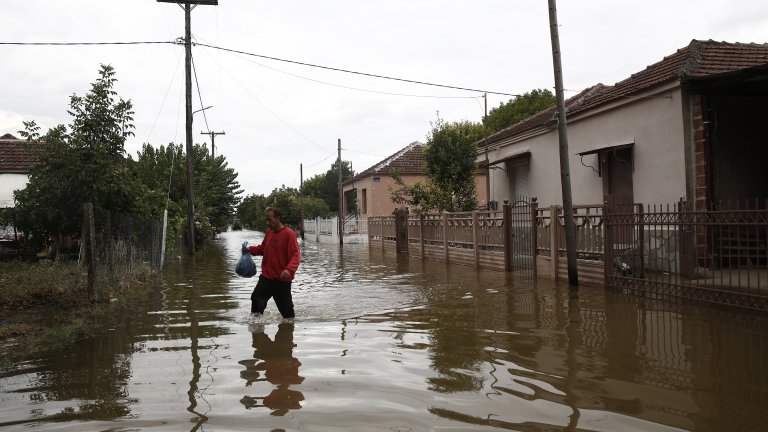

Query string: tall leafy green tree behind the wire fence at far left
[15,65,149,245]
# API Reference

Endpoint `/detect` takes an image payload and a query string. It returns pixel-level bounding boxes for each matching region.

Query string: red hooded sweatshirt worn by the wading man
[248,227,301,281]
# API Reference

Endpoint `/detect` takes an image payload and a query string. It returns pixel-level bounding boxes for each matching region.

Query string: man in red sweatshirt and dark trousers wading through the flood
[243,207,301,319]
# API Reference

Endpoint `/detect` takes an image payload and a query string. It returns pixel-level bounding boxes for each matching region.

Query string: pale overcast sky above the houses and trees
[0,0,768,195]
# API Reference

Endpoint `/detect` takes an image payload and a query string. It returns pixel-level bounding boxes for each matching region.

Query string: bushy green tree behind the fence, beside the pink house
[392,117,483,212]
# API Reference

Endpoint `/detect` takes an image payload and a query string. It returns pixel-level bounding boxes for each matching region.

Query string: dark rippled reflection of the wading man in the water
[238,322,304,416]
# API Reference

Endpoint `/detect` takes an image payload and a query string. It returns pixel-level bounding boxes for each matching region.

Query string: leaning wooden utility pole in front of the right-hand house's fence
[549,0,579,286]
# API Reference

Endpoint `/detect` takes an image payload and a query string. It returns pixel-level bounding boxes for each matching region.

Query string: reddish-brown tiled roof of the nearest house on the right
[478,40,768,145]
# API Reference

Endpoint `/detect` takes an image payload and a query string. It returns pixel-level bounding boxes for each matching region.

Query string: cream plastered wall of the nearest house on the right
[482,86,687,206]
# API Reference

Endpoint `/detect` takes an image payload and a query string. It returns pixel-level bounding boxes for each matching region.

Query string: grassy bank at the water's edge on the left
[0,261,156,369]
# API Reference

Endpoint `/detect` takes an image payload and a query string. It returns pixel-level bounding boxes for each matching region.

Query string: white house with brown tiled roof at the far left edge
[0,134,42,240]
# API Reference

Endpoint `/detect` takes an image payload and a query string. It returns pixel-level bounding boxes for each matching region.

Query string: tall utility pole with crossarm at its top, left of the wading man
[157,0,219,256]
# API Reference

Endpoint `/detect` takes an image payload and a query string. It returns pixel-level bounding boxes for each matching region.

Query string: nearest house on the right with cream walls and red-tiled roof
[477,40,768,208]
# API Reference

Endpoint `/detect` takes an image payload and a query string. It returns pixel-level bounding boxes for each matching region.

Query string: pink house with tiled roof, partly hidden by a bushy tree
[342,141,487,219]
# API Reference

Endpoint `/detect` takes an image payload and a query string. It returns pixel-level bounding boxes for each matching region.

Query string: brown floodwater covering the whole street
[0,231,768,432]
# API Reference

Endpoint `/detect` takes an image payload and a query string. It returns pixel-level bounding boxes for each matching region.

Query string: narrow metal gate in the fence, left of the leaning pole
[504,198,538,278]
